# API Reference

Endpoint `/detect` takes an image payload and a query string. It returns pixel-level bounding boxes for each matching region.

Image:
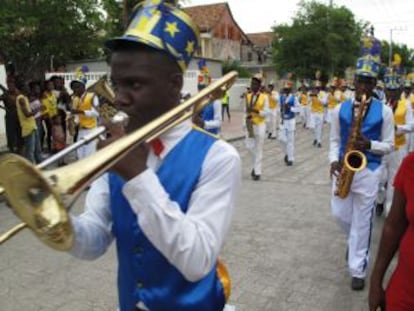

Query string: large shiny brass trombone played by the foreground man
[0,71,237,250]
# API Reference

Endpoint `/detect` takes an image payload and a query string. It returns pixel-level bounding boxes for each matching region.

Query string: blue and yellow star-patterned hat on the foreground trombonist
[106,0,200,72]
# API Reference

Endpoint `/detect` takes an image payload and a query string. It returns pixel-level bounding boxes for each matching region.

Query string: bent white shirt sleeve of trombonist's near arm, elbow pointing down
[123,141,241,281]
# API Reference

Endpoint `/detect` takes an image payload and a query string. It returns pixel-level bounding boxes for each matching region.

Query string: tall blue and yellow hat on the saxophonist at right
[355,36,381,78]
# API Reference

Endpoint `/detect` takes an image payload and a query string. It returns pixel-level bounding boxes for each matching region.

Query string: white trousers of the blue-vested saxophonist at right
[331,168,381,278]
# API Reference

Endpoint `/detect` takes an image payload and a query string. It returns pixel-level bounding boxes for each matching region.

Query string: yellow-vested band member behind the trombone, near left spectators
[70,76,99,159]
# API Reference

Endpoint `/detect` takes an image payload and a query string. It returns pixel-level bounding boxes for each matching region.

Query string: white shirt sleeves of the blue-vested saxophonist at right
[329,100,394,163]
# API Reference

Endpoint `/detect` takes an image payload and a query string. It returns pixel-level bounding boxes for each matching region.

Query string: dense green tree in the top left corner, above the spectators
[0,0,104,78]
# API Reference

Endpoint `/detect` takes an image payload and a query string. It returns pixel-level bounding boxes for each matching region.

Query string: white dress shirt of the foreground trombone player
[70,121,241,281]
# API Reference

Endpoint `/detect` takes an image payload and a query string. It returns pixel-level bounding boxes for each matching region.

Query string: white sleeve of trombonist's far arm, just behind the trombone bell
[70,174,113,260]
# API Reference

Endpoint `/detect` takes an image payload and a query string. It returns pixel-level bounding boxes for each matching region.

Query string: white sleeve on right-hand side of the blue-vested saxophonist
[369,105,395,155]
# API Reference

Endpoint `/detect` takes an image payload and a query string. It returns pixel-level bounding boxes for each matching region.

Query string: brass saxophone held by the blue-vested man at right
[335,95,368,199]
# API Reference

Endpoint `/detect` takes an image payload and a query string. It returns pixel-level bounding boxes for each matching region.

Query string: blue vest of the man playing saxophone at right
[339,99,383,171]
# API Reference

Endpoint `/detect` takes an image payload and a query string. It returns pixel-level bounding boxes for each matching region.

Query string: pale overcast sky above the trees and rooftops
[184,0,414,49]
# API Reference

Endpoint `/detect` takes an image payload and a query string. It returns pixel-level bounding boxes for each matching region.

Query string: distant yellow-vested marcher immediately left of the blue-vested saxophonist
[310,81,328,148]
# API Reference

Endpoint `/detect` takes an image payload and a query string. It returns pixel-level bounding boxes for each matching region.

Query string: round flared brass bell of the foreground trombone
[0,154,73,251]
